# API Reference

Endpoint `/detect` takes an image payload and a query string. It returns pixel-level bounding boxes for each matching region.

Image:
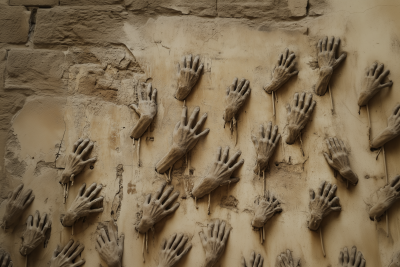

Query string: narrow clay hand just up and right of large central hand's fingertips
[222,78,251,122]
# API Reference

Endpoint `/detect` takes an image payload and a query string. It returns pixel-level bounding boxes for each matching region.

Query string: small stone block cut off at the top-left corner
[0,6,31,43]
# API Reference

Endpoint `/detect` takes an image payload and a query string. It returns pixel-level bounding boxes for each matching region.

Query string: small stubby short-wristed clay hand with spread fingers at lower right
[251,191,282,228]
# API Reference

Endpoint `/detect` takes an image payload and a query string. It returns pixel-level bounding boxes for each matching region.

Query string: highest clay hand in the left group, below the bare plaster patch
[59,139,97,184]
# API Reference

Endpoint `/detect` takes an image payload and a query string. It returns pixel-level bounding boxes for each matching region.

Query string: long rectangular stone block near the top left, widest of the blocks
[33,6,128,45]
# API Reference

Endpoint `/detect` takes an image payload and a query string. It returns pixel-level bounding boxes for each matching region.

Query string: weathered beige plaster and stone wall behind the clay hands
[0,0,400,266]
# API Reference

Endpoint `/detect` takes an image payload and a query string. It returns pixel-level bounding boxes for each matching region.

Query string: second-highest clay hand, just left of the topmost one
[264,48,299,94]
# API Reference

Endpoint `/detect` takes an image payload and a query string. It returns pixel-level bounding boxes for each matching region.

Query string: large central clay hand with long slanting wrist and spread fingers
[156,106,210,173]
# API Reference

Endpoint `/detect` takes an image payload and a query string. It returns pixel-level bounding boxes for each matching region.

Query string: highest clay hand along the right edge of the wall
[358,63,393,107]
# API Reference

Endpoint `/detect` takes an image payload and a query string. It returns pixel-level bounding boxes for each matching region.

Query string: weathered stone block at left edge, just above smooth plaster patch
[4,49,66,93]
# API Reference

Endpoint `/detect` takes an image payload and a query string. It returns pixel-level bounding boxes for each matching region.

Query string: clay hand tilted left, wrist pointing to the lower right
[324,137,358,185]
